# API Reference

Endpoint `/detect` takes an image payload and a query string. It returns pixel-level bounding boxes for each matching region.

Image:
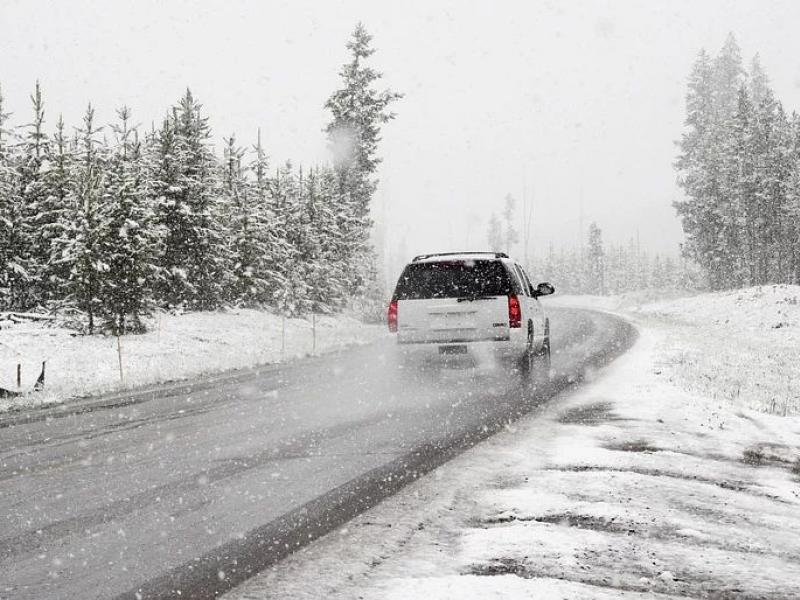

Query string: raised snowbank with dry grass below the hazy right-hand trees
[549,285,800,415]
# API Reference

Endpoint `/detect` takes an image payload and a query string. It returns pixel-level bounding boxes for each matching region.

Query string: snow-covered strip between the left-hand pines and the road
[0,309,385,411]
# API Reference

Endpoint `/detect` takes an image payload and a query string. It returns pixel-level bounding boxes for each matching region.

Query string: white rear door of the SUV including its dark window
[394,259,516,343]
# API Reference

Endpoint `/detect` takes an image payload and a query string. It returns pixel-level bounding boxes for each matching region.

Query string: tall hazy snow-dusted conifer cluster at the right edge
[675,36,800,290]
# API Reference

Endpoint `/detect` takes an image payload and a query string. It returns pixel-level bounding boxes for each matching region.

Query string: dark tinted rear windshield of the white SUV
[395,260,512,300]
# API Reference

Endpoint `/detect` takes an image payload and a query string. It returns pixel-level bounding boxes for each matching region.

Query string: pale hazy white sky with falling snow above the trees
[0,0,800,276]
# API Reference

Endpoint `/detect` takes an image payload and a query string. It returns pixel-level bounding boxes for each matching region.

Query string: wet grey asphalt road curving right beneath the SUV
[0,308,635,600]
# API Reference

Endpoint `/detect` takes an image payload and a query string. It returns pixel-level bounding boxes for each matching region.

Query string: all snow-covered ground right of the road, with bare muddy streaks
[223,286,800,600]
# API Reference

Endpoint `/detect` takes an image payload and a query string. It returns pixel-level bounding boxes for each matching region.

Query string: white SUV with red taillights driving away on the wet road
[388,252,555,379]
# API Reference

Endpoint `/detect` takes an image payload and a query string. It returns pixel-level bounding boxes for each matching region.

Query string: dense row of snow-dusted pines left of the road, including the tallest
[0,25,400,334]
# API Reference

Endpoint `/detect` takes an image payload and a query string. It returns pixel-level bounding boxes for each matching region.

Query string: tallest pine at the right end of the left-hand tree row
[325,23,402,294]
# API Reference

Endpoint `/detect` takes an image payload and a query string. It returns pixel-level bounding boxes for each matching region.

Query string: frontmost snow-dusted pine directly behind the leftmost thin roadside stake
[97,107,161,335]
